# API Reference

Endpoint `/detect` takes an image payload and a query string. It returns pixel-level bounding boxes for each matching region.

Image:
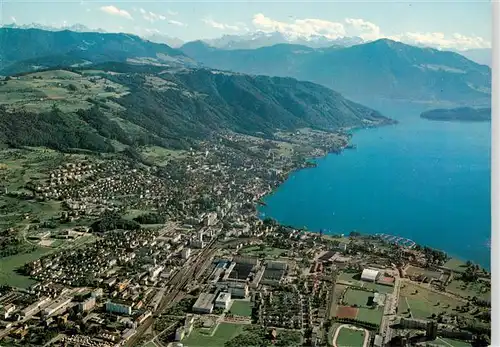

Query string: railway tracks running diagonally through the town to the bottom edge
[125,239,215,347]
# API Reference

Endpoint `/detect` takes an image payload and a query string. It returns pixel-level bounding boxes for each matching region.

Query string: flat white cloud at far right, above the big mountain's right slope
[388,32,491,50]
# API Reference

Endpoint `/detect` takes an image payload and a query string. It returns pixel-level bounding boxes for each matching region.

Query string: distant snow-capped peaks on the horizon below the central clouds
[199,31,364,49]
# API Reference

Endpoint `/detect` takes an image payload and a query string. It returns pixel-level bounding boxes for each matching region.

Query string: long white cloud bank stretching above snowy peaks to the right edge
[252,13,491,50]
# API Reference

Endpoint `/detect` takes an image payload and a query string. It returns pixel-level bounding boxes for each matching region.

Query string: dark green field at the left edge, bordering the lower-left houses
[0,247,51,288]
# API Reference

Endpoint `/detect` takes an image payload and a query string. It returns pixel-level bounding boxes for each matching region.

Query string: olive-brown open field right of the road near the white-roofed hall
[398,283,462,319]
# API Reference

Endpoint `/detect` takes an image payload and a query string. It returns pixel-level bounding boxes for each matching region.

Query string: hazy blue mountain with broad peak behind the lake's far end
[181,39,491,105]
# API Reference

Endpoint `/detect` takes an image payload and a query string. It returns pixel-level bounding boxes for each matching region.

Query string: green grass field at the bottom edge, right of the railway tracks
[182,323,245,347]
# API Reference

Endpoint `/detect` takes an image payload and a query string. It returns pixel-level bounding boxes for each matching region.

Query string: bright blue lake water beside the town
[260,103,491,269]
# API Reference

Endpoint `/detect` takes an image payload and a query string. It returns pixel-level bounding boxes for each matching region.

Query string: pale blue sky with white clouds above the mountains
[0,0,492,50]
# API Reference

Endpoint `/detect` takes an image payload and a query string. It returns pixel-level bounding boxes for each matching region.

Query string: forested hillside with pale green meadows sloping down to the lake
[0,62,393,152]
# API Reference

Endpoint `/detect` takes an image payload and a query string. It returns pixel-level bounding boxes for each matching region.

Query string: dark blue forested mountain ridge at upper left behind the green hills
[0,27,194,75]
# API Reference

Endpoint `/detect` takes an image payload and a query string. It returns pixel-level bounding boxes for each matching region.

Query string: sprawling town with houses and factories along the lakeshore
[0,129,491,347]
